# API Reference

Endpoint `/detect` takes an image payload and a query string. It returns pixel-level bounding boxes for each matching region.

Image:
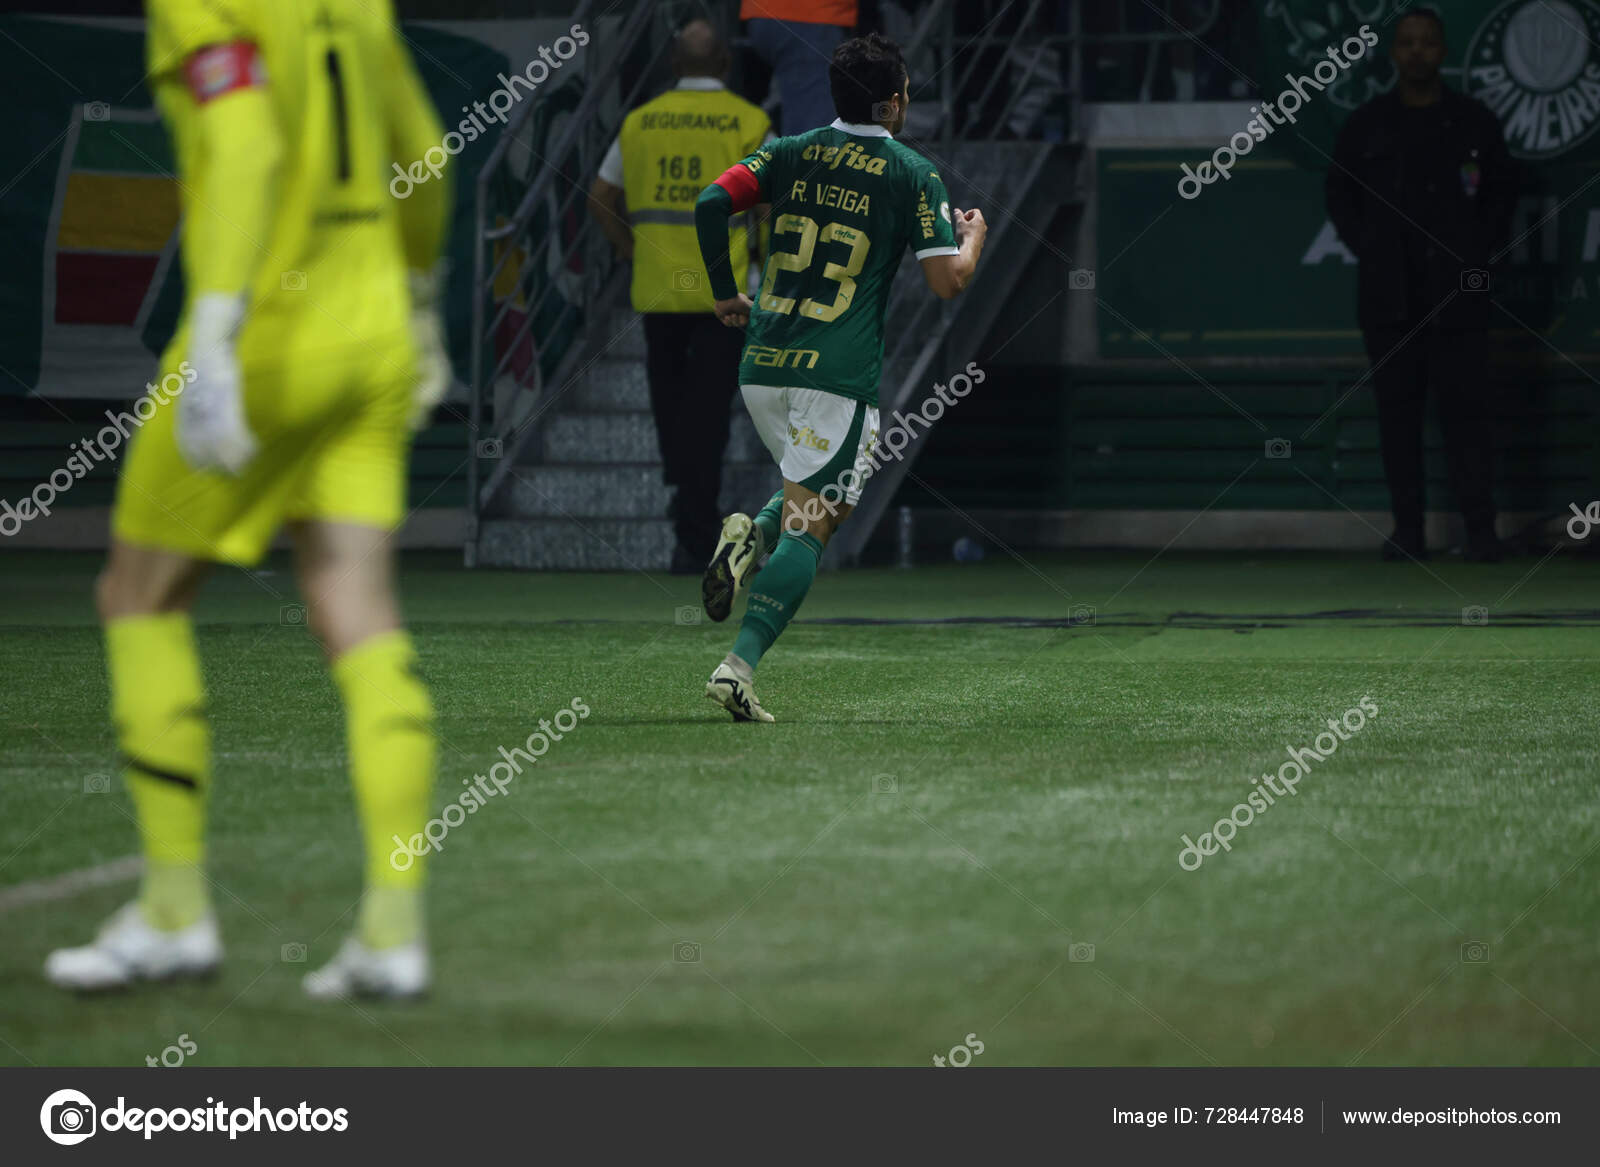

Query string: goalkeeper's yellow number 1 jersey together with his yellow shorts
[112,0,450,563]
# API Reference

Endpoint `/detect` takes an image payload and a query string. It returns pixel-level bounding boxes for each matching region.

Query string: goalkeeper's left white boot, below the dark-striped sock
[45,903,222,993]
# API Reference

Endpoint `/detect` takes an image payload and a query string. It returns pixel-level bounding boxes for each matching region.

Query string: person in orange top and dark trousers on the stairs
[739,0,856,136]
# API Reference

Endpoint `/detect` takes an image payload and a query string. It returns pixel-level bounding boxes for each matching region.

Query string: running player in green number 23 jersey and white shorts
[694,35,987,722]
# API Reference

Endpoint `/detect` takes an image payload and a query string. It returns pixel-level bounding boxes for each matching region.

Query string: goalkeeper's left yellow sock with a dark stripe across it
[106,612,211,930]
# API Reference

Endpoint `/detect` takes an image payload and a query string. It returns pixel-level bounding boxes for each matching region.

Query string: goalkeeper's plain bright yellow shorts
[112,336,416,567]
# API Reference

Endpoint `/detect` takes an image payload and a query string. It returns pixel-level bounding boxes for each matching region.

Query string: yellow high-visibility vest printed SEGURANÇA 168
[618,88,770,312]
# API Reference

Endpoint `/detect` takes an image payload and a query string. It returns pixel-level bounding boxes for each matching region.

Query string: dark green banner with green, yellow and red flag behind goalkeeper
[0,16,581,399]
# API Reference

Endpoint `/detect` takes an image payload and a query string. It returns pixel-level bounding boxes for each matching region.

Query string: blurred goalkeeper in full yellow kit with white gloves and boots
[46,0,450,997]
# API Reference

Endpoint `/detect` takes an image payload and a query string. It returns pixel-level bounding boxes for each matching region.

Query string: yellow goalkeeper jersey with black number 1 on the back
[147,0,450,363]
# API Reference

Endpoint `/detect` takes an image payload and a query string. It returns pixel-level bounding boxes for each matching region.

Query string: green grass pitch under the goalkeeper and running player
[0,552,1600,1066]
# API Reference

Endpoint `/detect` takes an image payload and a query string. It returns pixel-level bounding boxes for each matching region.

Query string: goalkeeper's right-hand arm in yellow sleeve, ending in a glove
[387,25,451,429]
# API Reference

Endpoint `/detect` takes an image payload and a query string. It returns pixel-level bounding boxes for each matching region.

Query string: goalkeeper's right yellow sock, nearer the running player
[333,631,435,948]
